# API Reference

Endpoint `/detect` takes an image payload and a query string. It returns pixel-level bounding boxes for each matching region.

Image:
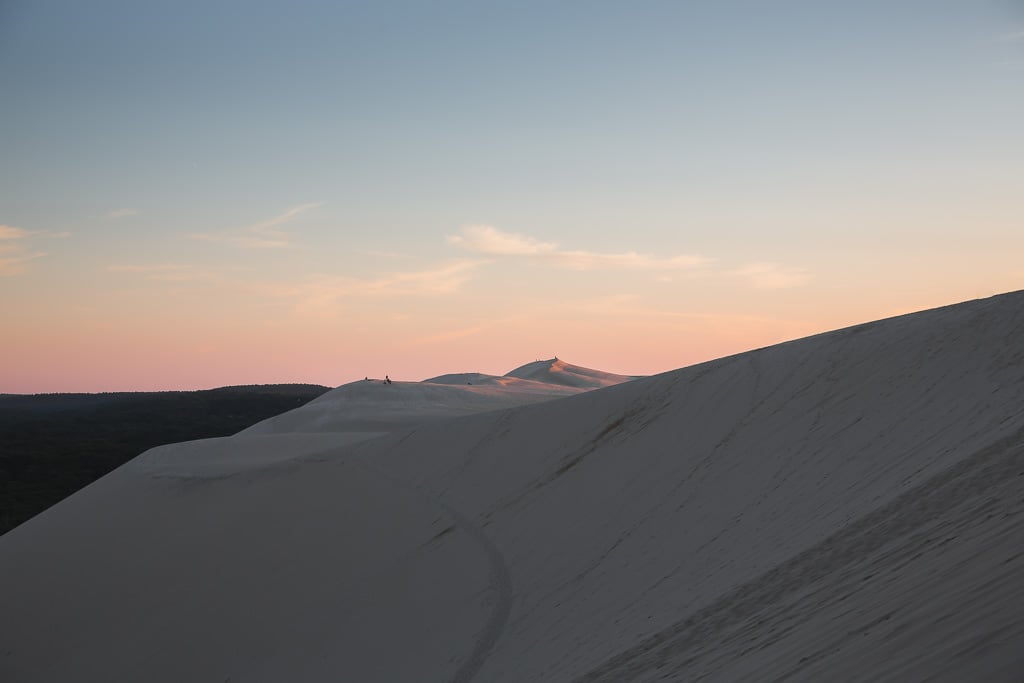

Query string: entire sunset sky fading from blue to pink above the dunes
[0,0,1024,393]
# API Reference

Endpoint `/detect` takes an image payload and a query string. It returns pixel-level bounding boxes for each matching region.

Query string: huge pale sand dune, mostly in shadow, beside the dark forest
[0,292,1024,683]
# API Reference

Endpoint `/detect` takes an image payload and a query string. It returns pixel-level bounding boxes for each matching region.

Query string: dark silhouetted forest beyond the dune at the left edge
[0,384,329,533]
